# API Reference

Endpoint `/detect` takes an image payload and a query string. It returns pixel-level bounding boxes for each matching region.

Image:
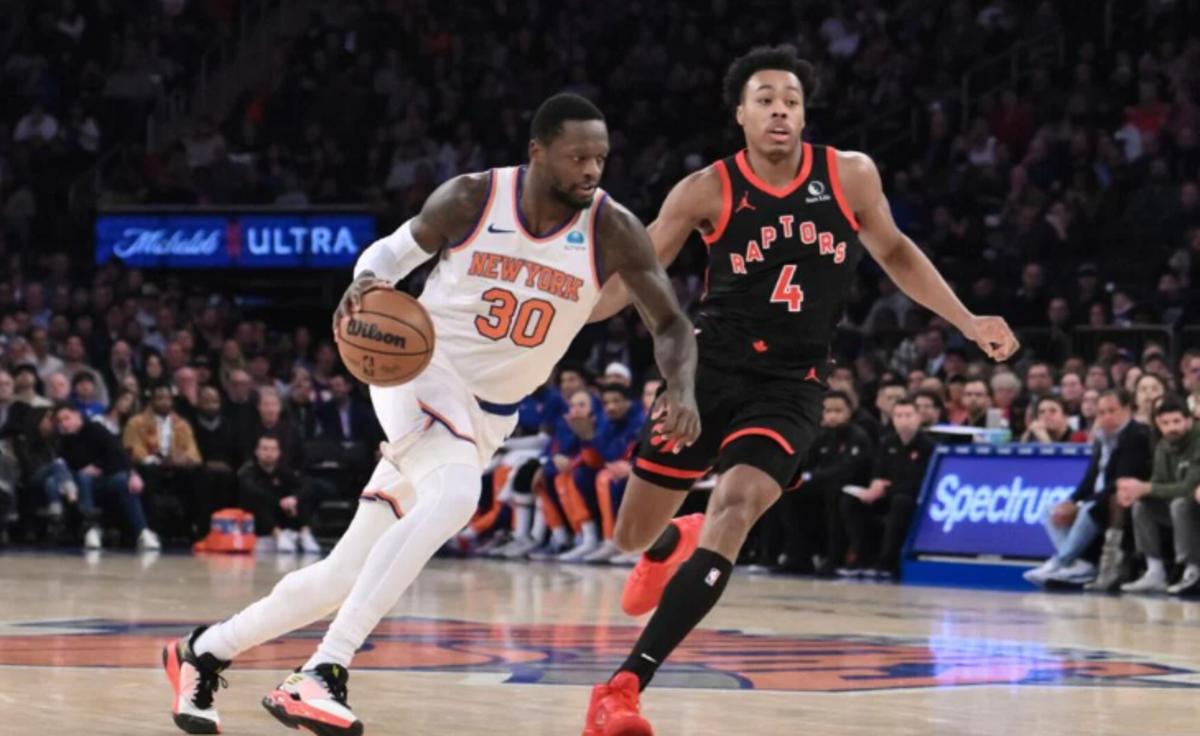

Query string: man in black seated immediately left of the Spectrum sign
[840,399,934,579]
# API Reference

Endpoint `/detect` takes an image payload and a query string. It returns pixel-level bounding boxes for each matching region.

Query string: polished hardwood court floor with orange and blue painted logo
[0,552,1200,736]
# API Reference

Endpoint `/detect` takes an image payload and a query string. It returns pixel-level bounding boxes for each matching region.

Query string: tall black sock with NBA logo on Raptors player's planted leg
[618,549,733,689]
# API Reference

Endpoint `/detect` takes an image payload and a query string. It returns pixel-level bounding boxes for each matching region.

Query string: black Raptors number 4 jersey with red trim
[696,143,863,378]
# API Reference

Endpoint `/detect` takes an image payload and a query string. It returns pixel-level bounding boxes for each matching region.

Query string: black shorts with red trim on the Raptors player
[634,363,826,491]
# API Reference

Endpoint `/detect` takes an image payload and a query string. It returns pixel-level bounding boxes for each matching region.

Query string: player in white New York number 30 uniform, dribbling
[163,94,700,736]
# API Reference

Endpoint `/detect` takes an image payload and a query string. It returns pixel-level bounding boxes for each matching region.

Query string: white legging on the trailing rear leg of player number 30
[194,502,396,660]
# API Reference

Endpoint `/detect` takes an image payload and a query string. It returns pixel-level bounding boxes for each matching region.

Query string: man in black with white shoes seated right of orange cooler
[238,433,320,555]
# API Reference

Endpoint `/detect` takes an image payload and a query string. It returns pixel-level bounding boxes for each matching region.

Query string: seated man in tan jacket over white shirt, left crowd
[122,383,206,539]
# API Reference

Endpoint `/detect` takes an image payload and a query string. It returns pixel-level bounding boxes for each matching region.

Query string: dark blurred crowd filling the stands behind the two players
[0,0,1200,590]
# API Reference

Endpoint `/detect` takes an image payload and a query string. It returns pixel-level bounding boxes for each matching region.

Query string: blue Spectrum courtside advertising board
[908,444,1091,558]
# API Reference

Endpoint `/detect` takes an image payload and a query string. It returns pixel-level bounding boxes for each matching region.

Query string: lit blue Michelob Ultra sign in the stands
[96,210,377,269]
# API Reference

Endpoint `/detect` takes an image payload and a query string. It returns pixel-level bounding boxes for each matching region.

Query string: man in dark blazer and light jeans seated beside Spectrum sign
[1025,389,1152,590]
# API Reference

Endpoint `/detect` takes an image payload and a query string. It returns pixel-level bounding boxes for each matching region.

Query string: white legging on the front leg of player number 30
[302,465,480,670]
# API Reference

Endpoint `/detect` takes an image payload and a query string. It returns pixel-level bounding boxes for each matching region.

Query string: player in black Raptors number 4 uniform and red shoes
[583,47,1018,736]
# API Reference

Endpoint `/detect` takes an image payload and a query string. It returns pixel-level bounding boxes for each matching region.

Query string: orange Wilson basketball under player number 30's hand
[337,289,433,387]
